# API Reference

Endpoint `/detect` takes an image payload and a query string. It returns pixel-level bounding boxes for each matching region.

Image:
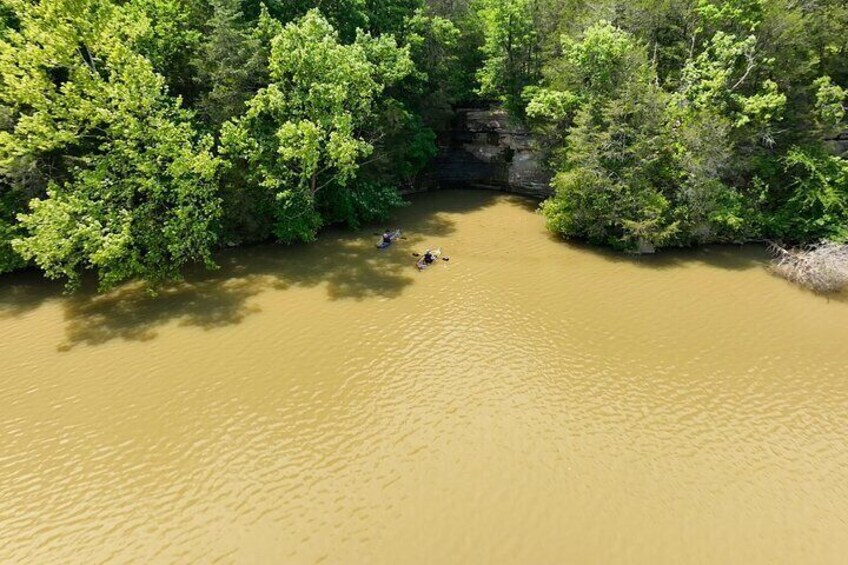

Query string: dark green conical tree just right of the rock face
[543,83,680,251]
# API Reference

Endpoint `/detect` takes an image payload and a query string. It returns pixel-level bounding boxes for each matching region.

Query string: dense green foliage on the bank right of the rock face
[458,0,848,250]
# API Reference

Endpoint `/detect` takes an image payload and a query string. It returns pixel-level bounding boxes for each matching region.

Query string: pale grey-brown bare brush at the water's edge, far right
[769,241,848,294]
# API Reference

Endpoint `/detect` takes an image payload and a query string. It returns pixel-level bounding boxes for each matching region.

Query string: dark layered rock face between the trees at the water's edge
[416,108,552,198]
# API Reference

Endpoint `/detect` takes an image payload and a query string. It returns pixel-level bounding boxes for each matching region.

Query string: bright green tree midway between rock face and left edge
[222,11,412,242]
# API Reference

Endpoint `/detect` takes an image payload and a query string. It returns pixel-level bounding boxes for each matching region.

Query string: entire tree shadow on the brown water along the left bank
[0,192,497,350]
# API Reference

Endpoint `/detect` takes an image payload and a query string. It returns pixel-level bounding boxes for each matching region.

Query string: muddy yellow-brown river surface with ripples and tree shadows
[0,191,848,565]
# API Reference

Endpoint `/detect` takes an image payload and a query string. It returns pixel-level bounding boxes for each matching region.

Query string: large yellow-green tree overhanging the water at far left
[0,0,220,288]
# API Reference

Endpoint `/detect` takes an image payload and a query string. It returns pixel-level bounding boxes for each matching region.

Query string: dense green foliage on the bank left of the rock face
[0,0,468,288]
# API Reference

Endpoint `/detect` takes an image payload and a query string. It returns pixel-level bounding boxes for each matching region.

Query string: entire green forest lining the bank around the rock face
[0,0,848,289]
